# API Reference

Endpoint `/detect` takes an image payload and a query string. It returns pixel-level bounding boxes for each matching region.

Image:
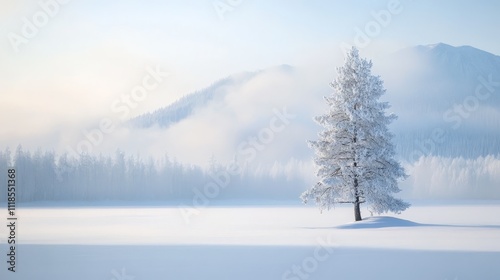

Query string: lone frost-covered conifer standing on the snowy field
[302,47,410,221]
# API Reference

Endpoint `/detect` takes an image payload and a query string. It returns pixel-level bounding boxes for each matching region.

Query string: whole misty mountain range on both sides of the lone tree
[131,43,500,162]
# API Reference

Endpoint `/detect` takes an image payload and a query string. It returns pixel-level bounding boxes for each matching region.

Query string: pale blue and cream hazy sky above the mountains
[0,0,500,142]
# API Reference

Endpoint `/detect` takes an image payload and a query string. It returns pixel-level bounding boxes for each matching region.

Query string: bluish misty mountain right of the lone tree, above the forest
[381,43,500,161]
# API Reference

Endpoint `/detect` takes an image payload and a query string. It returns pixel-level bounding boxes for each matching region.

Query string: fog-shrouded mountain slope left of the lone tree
[119,65,316,166]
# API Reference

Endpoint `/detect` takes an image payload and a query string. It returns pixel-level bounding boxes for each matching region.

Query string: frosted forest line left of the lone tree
[0,147,305,202]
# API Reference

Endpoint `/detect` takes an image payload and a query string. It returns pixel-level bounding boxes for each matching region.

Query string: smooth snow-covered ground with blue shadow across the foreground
[0,201,500,280]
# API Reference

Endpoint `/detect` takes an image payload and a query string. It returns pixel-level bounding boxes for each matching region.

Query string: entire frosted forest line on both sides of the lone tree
[0,148,500,201]
